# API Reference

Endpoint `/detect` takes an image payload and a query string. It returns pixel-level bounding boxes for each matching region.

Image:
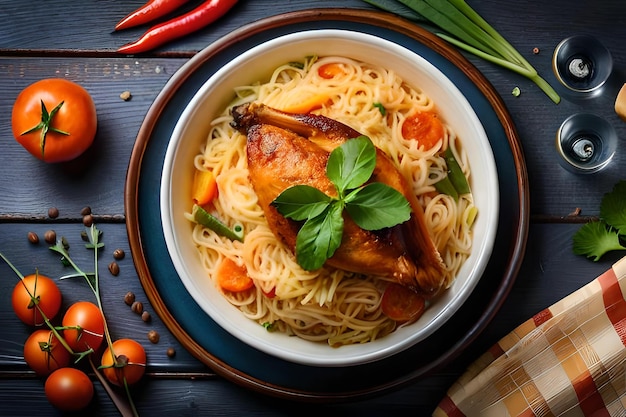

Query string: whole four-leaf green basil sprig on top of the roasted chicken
[272,136,411,271]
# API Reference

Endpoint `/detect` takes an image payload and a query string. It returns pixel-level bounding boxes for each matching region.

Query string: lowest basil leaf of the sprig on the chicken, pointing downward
[296,201,343,271]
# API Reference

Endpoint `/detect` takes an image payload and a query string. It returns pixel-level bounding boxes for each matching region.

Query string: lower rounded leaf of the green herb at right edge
[573,221,626,262]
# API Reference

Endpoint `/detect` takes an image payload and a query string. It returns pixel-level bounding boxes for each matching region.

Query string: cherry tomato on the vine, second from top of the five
[61,301,104,352]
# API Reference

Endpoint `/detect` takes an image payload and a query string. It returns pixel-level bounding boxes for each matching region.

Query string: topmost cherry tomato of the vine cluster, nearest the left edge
[11,274,62,326]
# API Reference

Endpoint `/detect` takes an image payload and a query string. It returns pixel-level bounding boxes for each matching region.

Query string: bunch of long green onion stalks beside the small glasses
[363,0,561,104]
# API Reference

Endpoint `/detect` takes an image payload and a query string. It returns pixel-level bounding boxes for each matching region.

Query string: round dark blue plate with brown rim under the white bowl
[125,9,529,400]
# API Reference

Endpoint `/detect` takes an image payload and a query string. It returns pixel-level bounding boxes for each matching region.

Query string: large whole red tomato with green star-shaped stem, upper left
[11,78,98,162]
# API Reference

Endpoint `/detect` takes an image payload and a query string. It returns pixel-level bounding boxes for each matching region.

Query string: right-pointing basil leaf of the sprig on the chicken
[346,182,411,230]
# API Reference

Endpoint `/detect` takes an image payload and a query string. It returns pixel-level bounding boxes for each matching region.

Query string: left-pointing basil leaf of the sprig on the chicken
[272,185,332,220]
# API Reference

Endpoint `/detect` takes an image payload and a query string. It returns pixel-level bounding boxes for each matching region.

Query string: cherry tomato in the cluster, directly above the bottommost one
[24,329,72,376]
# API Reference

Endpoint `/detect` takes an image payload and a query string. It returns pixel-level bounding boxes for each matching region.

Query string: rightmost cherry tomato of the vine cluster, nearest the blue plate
[101,339,146,387]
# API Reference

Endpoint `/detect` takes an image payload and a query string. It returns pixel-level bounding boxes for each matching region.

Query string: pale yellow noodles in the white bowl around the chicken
[186,57,476,346]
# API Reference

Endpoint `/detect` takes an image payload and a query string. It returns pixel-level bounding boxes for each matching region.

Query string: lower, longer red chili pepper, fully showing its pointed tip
[117,0,237,54]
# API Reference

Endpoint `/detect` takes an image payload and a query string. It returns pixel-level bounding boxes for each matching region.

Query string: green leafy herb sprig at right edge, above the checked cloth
[573,181,626,262]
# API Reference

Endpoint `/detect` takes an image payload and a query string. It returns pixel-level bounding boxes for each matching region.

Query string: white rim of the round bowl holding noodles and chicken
[160,29,499,366]
